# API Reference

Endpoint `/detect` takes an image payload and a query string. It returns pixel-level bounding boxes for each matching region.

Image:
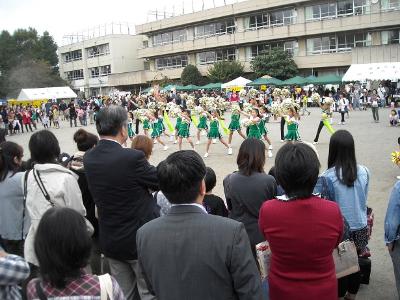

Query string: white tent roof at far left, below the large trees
[17,86,77,100]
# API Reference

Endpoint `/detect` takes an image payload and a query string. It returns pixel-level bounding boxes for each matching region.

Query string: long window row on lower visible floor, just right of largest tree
[307,32,371,55]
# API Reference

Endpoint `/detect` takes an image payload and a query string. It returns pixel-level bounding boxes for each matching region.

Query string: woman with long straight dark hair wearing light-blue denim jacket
[322,130,369,300]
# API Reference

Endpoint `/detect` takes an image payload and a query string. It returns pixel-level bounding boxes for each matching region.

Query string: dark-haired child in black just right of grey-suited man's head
[203,167,228,217]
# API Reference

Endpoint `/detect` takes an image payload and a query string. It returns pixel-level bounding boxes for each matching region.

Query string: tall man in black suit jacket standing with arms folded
[83,105,159,300]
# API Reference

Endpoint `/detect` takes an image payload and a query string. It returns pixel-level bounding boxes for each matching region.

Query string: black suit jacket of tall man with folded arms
[83,140,159,260]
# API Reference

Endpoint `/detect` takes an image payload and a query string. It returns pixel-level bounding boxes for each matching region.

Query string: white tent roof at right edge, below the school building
[342,62,400,82]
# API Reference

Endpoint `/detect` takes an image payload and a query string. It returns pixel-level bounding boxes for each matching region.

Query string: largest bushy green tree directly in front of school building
[251,48,298,80]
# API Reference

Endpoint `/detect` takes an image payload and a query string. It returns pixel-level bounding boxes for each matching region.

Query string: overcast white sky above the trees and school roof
[0,0,244,44]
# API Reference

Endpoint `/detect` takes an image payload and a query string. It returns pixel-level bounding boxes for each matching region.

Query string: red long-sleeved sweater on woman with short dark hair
[259,197,343,300]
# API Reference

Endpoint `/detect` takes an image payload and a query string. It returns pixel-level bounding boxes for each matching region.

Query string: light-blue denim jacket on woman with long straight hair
[322,165,369,230]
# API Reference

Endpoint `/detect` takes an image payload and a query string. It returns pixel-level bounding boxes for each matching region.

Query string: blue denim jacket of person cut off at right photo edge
[385,181,400,244]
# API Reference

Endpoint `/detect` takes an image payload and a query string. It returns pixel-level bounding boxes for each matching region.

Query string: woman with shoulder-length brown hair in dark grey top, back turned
[223,138,277,254]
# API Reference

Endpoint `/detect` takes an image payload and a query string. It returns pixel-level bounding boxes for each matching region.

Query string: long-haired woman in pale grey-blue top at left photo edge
[0,142,30,256]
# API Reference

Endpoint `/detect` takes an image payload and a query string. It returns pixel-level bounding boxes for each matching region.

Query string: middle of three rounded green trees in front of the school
[207,60,244,82]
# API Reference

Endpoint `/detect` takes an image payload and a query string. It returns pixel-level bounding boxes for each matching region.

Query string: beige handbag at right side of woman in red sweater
[332,240,360,279]
